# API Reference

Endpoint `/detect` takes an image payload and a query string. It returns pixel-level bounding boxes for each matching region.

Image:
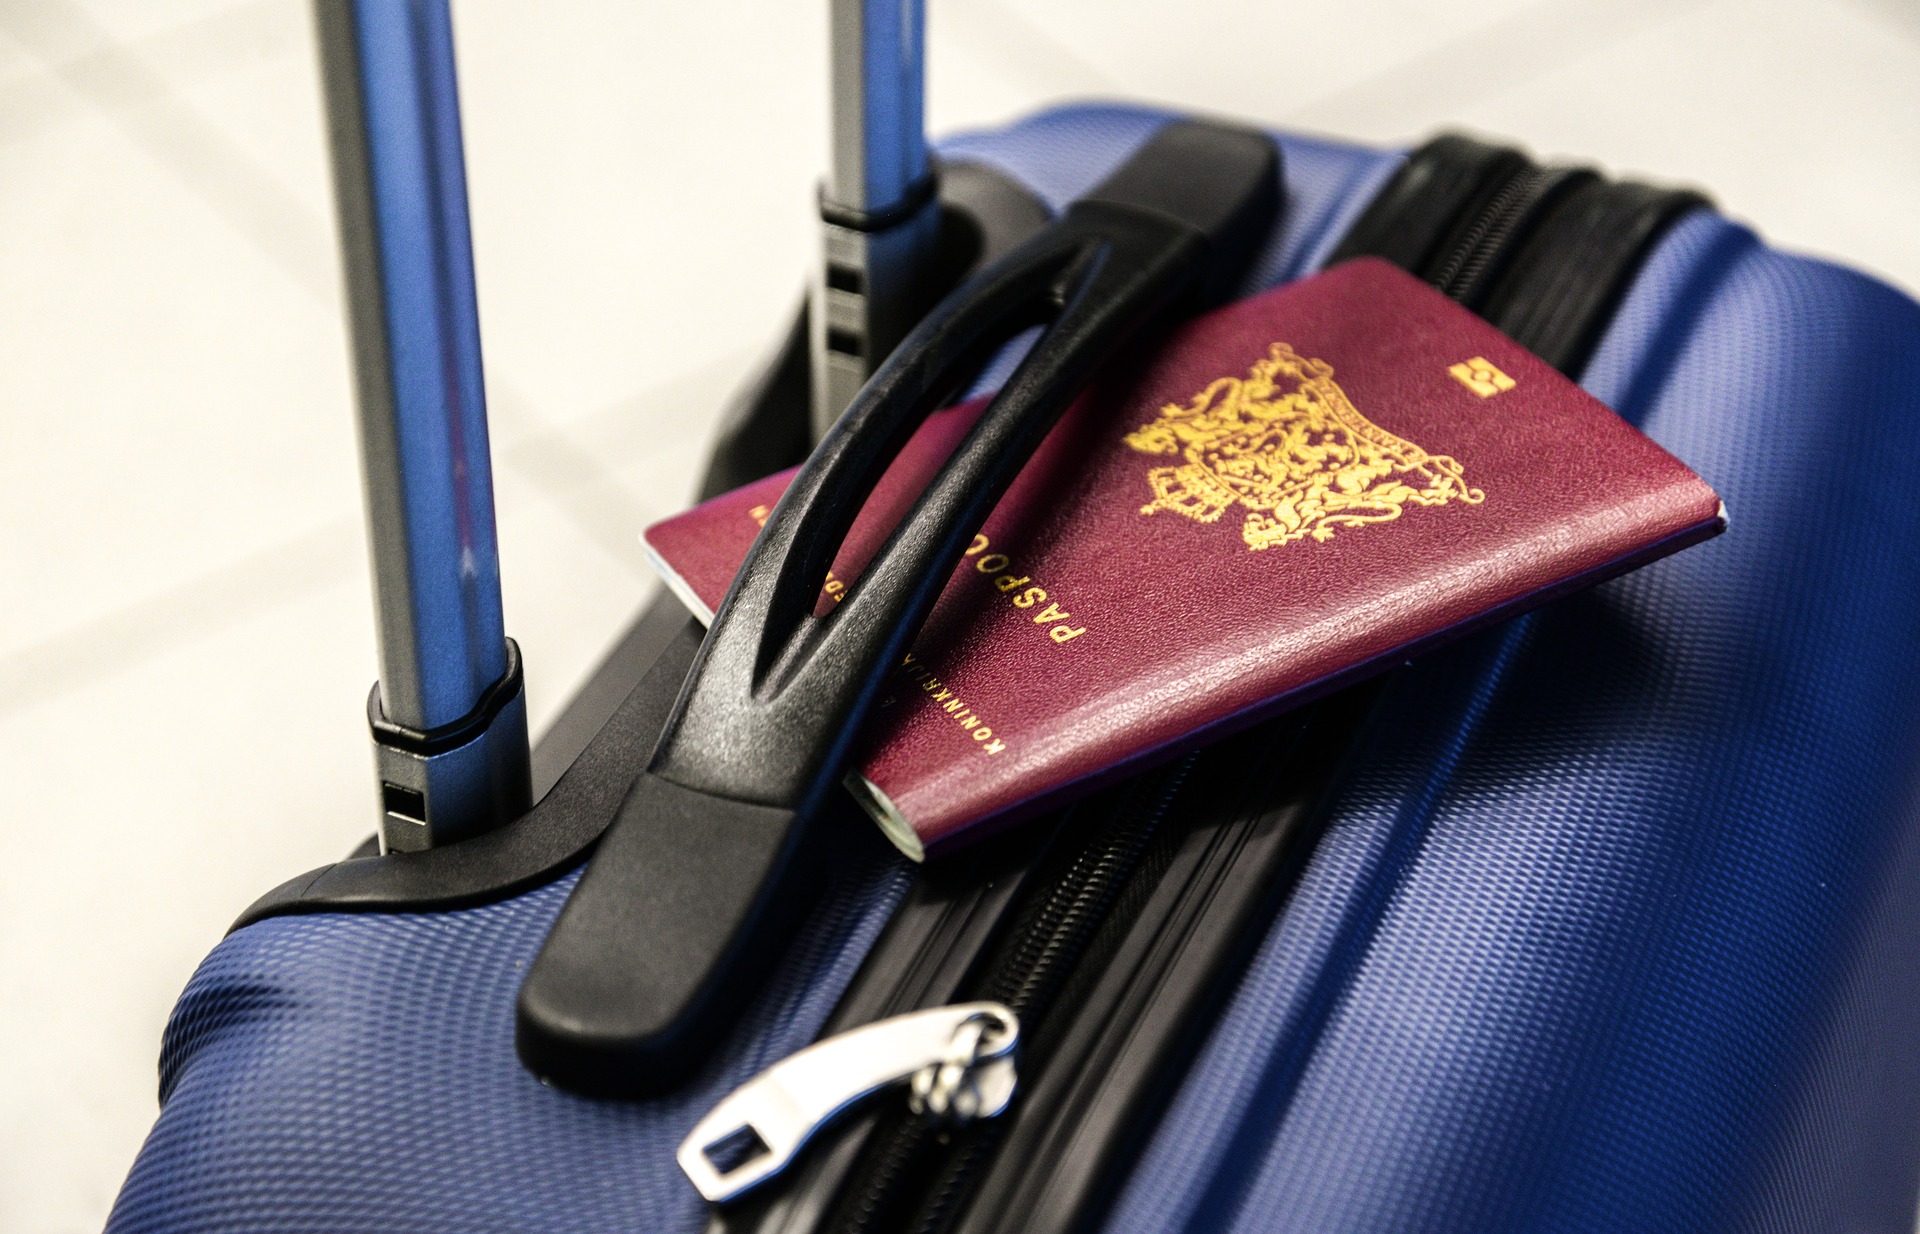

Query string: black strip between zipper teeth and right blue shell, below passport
[904,683,1377,1234]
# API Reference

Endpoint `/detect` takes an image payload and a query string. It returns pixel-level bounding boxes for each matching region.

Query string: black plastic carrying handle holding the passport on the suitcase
[516,121,1281,1094]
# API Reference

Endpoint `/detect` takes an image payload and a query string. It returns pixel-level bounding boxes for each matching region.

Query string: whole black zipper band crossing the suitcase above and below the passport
[708,136,1703,1234]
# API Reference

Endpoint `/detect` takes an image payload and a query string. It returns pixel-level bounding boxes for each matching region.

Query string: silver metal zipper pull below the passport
[678,1002,1020,1203]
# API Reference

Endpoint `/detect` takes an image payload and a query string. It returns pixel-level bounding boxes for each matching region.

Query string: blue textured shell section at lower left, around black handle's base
[108,859,908,1234]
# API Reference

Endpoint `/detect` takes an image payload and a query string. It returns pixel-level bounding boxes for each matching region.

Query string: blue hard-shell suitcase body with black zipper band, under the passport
[109,2,1920,1232]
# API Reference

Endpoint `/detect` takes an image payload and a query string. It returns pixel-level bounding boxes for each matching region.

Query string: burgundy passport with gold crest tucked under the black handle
[645,259,1726,858]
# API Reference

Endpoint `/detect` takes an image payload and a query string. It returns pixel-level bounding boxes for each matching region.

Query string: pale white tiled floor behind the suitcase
[0,0,1920,1232]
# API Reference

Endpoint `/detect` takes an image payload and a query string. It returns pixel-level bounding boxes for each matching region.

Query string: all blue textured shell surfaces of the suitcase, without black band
[109,107,1920,1232]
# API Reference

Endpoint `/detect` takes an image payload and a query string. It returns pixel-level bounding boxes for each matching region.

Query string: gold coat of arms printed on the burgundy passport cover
[1127,344,1486,553]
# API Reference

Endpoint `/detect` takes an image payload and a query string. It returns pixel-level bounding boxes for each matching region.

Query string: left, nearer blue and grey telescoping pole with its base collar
[315,0,532,852]
